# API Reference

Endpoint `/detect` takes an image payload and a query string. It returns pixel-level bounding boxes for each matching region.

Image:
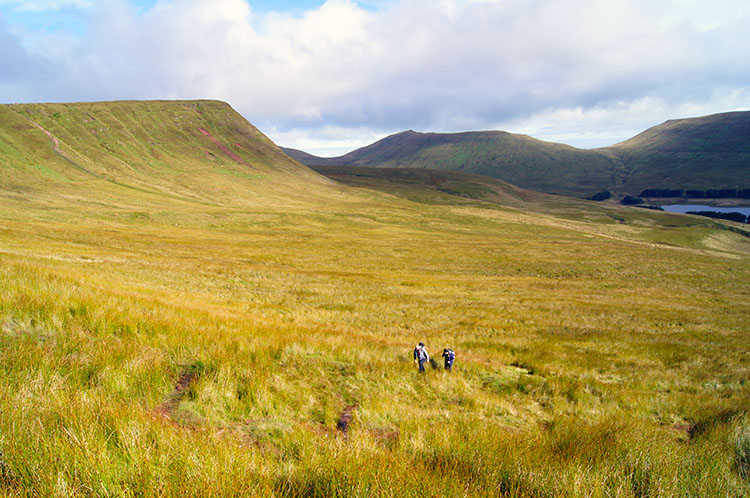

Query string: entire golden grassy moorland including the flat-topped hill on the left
[0,102,750,497]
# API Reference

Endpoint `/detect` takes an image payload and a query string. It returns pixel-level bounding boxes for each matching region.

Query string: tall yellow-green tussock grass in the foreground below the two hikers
[0,235,750,497]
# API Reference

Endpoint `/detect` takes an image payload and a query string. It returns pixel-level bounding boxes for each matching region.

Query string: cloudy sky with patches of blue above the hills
[0,0,750,155]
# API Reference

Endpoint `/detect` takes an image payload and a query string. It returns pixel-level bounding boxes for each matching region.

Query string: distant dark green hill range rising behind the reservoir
[283,112,750,197]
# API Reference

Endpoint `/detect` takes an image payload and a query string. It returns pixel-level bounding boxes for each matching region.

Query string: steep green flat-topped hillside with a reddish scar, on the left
[0,101,325,208]
